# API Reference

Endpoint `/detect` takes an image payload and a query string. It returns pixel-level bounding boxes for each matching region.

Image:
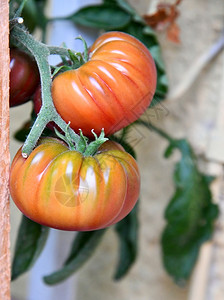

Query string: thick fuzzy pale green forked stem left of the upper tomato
[11,25,80,157]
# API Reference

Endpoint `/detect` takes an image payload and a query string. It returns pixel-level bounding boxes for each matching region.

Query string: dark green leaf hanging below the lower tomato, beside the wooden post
[12,216,49,280]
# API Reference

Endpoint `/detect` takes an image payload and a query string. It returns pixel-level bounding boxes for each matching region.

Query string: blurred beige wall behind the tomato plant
[11,0,224,300]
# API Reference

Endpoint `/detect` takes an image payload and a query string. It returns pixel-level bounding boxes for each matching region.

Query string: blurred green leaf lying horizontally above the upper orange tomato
[68,4,131,30]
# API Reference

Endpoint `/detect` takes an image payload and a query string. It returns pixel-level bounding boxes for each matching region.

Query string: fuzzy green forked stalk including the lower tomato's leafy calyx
[11,24,107,158]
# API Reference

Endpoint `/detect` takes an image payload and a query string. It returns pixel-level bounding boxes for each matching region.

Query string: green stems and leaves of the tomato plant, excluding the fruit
[10,0,218,284]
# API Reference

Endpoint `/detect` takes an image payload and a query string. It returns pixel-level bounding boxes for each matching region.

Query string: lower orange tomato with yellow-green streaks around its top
[10,138,140,231]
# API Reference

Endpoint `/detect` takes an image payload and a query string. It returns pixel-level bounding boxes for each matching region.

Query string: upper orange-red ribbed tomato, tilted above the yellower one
[52,32,156,137]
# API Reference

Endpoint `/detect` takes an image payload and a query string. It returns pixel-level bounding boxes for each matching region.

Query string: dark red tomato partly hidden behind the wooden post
[9,48,40,107]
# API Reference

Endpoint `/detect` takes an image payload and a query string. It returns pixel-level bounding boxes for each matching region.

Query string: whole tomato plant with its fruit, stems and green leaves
[10,0,218,284]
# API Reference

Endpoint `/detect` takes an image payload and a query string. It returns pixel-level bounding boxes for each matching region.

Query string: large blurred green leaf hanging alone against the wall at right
[162,140,218,283]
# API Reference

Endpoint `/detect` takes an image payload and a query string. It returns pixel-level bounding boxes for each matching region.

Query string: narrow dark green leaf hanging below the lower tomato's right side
[114,204,138,280]
